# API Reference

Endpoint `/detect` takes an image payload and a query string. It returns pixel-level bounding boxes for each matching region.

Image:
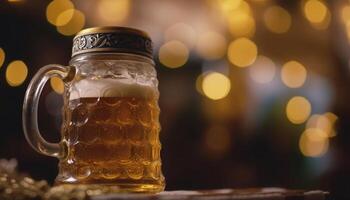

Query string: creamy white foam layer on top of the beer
[69,79,156,100]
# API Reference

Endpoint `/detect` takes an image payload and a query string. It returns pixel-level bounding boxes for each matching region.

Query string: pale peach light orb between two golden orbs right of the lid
[196,31,227,60]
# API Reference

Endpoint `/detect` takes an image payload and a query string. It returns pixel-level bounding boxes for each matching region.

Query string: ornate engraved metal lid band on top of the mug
[72,27,153,58]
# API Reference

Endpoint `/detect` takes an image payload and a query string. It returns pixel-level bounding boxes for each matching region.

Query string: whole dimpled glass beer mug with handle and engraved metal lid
[23,27,165,192]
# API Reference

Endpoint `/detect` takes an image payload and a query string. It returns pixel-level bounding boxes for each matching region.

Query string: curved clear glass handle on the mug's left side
[22,65,75,158]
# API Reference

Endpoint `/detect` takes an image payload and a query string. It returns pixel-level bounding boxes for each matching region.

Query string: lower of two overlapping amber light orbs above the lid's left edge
[57,10,85,36]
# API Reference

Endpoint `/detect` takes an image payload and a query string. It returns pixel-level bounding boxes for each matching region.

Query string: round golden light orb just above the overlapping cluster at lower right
[286,96,311,124]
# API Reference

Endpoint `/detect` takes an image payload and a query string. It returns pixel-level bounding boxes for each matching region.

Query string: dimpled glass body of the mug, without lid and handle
[56,53,164,192]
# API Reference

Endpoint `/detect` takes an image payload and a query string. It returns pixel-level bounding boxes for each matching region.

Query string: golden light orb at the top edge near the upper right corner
[304,0,328,23]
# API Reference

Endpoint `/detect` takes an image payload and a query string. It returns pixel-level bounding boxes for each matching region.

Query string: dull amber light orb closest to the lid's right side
[159,40,189,68]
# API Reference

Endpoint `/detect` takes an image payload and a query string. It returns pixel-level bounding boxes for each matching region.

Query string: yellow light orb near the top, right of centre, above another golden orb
[228,10,255,37]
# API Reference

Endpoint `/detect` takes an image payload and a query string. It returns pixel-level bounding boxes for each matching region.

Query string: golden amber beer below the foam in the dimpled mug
[57,83,164,191]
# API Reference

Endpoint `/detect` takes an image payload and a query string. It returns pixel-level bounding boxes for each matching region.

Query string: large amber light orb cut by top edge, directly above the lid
[97,0,131,25]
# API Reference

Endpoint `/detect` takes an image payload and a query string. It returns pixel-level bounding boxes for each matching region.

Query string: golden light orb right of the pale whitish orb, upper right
[281,61,307,88]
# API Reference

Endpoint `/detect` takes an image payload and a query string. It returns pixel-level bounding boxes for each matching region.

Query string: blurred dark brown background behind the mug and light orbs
[0,0,350,197]
